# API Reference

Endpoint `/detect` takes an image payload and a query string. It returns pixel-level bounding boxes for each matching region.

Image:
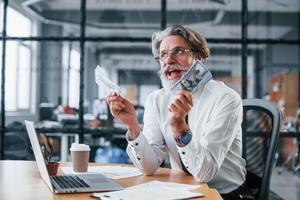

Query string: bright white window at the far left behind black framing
[0,5,32,112]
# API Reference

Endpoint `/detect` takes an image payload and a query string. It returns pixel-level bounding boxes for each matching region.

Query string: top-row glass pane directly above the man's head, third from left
[167,0,241,39]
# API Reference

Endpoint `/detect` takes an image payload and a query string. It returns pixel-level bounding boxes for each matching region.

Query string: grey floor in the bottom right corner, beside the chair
[271,168,300,200]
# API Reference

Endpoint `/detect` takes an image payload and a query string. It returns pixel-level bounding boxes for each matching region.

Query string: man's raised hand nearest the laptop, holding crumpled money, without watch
[106,92,140,140]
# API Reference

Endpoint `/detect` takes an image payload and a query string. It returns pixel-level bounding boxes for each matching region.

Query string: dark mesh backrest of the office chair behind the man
[242,99,282,200]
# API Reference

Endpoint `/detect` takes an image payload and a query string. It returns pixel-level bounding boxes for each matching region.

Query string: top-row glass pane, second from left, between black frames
[86,0,161,38]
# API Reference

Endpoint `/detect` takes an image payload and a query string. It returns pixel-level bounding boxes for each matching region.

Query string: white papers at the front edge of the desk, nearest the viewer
[93,181,203,200]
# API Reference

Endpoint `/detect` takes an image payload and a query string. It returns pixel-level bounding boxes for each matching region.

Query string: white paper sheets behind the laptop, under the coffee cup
[61,166,142,179]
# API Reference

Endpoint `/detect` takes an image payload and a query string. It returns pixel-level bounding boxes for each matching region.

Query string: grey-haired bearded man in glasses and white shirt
[107,25,246,199]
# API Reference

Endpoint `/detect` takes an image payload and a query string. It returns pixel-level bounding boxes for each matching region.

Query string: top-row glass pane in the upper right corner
[248,0,300,40]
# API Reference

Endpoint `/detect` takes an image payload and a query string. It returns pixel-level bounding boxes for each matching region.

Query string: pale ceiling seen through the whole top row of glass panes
[17,0,300,39]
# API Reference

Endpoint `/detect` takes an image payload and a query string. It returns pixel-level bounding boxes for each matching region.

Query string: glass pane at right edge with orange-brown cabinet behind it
[252,44,300,131]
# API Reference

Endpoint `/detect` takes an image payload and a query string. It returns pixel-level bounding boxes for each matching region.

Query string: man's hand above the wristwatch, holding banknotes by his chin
[168,90,193,137]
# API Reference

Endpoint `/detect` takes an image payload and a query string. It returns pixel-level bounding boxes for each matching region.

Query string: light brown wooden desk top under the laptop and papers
[0,160,222,200]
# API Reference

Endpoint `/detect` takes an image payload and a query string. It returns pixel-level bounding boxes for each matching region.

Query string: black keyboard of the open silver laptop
[51,176,91,189]
